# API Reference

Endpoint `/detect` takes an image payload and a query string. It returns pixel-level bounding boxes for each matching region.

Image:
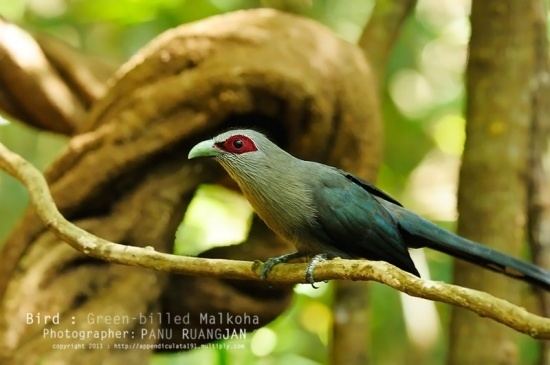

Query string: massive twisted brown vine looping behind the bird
[0,9,380,364]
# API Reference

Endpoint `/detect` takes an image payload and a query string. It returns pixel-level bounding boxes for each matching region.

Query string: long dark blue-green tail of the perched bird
[395,209,550,290]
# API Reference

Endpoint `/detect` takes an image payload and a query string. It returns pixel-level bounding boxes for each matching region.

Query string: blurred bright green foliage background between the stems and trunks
[0,0,538,365]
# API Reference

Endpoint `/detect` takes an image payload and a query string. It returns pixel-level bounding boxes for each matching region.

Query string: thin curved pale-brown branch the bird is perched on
[0,139,550,339]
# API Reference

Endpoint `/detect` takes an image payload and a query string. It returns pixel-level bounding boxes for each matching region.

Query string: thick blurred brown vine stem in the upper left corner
[0,19,111,134]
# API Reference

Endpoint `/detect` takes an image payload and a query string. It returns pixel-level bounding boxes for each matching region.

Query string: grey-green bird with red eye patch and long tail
[188,129,550,290]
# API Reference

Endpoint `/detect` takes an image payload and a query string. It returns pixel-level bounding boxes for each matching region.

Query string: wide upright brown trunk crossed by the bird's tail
[449,0,539,365]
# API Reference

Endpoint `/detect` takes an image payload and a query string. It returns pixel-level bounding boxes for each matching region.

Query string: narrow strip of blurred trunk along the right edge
[528,1,550,365]
